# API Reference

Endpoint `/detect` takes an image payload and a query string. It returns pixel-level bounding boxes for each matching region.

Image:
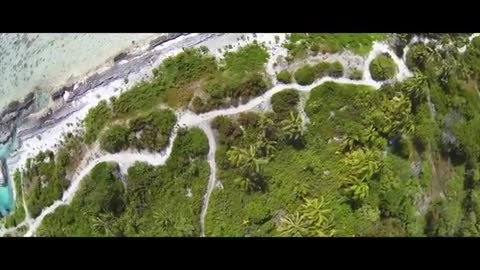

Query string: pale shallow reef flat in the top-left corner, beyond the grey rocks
[0,33,164,111]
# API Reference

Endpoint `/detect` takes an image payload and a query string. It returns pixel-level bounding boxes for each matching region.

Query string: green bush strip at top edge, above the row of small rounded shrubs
[284,33,386,58]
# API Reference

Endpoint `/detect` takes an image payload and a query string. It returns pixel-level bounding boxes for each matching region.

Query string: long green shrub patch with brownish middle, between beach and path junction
[85,43,270,129]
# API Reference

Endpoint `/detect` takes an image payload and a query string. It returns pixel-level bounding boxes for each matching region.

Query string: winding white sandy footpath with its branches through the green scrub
[6,33,472,237]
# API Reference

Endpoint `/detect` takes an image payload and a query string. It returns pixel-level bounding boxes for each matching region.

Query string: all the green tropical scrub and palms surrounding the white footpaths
[5,34,480,237]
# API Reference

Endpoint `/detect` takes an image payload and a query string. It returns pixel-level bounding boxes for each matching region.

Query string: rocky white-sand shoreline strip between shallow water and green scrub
[0,34,191,215]
